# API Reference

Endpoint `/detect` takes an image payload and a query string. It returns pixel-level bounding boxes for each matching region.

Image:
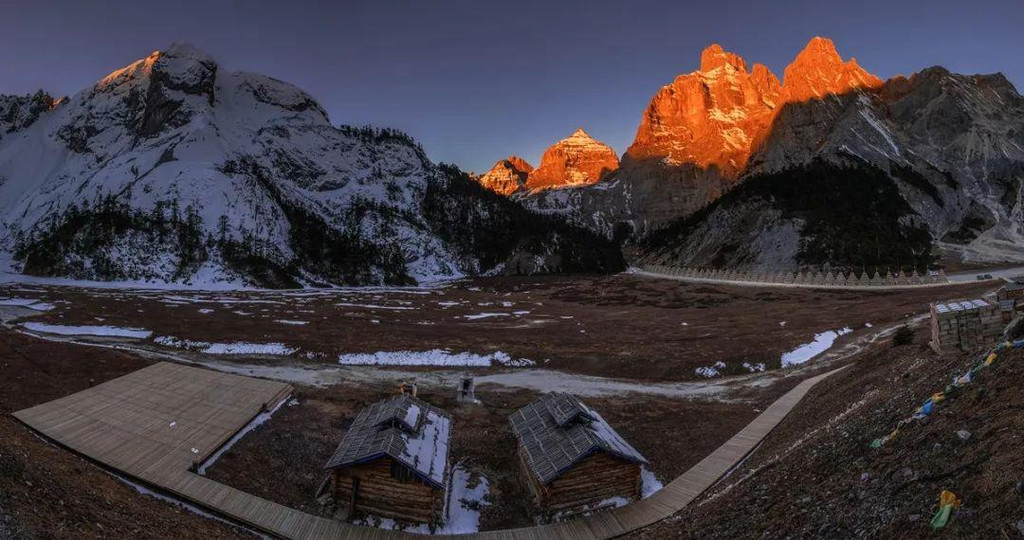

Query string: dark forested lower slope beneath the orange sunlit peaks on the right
[640,161,932,272]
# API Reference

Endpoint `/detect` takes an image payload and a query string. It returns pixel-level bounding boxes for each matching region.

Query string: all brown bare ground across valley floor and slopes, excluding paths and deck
[0,275,1007,538]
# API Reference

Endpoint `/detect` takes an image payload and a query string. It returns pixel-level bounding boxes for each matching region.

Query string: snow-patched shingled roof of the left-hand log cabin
[324,394,452,489]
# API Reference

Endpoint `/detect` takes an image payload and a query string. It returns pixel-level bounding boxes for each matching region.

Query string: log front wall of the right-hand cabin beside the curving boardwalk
[532,452,641,510]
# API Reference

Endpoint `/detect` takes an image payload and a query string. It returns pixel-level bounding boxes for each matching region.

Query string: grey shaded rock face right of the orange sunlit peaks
[748,68,1024,261]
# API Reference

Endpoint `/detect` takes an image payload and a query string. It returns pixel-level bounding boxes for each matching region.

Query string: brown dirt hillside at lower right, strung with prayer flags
[632,323,1024,539]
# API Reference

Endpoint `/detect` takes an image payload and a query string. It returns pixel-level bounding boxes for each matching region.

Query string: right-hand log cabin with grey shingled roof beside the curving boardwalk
[509,392,647,513]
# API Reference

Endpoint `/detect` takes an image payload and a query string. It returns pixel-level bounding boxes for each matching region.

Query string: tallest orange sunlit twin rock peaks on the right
[626,37,882,179]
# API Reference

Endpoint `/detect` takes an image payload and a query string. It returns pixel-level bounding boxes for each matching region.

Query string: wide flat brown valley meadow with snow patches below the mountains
[0,275,993,381]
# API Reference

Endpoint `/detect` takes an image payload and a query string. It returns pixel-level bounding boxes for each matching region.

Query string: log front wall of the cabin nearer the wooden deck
[334,457,444,524]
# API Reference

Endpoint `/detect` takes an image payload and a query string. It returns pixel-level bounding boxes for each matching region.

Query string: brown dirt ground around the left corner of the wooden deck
[0,328,252,539]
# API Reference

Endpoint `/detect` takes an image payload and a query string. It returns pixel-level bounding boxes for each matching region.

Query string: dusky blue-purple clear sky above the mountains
[0,0,1024,172]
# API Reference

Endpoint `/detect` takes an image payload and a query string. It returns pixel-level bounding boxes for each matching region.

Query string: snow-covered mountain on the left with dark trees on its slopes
[0,44,622,286]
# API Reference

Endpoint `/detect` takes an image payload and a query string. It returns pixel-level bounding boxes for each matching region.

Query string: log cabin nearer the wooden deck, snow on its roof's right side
[324,394,452,525]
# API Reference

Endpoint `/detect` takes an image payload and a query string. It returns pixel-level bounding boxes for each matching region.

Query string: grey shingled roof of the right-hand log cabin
[509,392,647,484]
